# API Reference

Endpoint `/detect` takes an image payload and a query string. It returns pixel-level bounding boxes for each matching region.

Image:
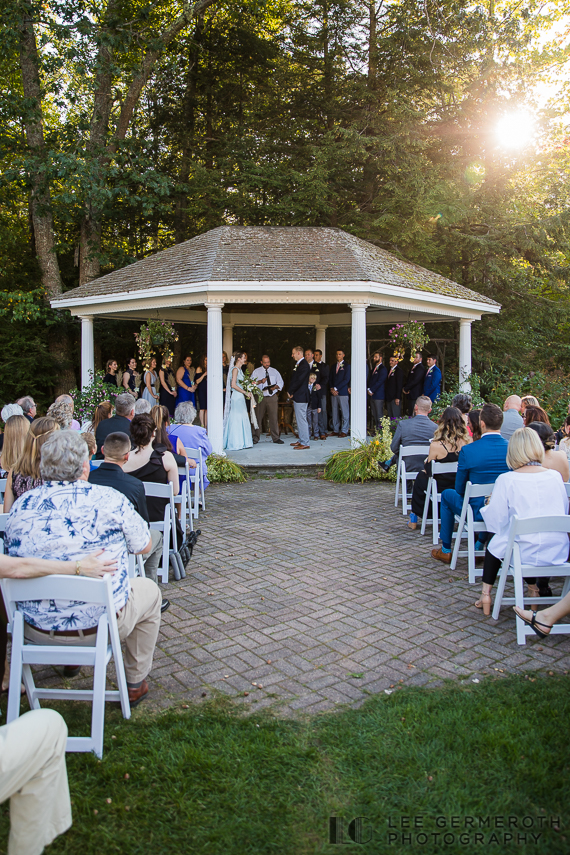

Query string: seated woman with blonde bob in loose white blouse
[475,428,568,615]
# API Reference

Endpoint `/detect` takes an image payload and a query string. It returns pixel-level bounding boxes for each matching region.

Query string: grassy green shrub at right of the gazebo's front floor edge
[322,418,396,484]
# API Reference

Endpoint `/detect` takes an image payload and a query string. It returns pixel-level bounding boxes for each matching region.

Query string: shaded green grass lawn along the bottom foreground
[0,676,570,855]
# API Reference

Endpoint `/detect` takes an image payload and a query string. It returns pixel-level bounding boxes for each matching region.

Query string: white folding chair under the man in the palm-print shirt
[0,575,131,757]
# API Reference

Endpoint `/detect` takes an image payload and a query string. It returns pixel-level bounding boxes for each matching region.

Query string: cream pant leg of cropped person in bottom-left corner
[0,710,71,855]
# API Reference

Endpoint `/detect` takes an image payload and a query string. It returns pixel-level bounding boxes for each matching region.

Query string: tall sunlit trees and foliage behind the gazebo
[0,0,570,408]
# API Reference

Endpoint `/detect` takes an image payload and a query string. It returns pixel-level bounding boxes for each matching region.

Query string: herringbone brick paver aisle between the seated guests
[150,478,570,715]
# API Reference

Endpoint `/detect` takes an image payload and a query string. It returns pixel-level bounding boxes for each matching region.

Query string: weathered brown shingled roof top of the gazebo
[52,226,499,313]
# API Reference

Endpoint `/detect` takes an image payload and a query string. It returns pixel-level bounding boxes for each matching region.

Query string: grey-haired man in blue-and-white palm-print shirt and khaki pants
[6,432,161,706]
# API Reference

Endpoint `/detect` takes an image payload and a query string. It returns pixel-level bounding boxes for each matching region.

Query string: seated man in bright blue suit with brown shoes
[431,404,509,564]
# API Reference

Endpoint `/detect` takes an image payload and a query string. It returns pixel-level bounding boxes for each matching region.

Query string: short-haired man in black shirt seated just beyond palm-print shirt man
[89,433,165,600]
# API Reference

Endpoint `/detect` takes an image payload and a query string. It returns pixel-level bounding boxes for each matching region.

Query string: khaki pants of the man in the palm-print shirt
[24,578,162,684]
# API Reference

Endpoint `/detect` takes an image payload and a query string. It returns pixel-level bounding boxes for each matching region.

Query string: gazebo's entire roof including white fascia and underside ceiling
[52,226,500,324]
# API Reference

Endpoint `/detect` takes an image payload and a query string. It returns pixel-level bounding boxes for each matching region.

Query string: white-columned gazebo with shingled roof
[51,226,500,453]
